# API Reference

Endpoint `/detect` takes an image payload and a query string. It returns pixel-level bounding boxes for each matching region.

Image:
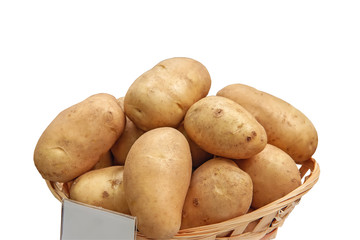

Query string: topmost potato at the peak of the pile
[124,57,211,131]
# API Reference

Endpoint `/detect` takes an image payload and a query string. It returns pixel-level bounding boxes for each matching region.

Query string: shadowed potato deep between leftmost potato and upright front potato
[111,97,144,165]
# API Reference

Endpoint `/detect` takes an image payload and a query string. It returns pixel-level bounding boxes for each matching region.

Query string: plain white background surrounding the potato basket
[0,0,360,240]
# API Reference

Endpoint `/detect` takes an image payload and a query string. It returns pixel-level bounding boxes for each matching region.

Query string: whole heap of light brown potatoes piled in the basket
[34,57,318,239]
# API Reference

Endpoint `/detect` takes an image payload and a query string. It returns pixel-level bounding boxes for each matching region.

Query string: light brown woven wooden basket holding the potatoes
[46,158,320,240]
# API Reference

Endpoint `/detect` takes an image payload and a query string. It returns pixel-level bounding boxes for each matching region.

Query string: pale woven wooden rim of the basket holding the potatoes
[45,158,320,239]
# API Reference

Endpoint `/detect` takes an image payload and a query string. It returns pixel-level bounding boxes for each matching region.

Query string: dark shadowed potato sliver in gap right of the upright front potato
[177,122,213,168]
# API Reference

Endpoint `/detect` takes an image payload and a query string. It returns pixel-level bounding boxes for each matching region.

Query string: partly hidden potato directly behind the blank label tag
[70,166,130,214]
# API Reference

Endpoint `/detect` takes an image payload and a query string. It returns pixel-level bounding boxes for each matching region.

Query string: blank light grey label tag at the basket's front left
[60,199,136,240]
